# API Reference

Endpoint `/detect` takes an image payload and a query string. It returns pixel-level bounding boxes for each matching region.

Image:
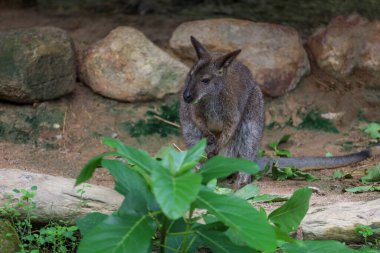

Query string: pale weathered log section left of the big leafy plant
[0,169,123,223]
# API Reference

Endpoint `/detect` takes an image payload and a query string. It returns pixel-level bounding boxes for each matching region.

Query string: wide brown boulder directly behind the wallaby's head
[170,18,310,97]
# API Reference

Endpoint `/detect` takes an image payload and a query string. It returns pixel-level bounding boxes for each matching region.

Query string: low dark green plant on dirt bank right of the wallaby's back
[298,110,339,133]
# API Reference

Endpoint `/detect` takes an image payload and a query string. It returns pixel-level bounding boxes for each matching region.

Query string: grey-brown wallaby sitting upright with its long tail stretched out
[180,36,370,188]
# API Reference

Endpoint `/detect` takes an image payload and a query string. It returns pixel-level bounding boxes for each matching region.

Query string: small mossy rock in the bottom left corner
[0,219,20,253]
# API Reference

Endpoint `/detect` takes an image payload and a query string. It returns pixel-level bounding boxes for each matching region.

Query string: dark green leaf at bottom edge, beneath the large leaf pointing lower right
[196,230,255,253]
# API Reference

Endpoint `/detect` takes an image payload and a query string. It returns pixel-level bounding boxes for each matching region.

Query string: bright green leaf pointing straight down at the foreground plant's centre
[152,169,202,219]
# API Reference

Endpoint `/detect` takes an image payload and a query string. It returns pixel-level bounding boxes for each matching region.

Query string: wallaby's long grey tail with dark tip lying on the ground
[256,150,371,170]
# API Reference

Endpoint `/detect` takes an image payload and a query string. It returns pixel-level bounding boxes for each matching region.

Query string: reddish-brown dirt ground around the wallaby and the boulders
[0,9,380,208]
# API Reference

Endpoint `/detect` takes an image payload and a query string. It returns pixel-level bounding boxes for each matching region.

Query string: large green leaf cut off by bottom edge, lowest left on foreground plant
[78,215,156,253]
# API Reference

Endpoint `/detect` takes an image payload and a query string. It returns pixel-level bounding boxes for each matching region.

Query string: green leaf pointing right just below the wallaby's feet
[199,156,260,183]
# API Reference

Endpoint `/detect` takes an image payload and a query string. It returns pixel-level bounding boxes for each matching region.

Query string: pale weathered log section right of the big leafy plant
[301,198,380,243]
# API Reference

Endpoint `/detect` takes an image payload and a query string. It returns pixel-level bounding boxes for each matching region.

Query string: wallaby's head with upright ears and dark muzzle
[183,36,241,103]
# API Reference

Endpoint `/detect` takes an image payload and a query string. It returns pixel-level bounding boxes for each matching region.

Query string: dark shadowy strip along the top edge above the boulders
[0,0,380,32]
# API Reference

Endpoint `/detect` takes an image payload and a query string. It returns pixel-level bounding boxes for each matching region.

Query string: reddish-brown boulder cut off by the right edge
[308,15,380,83]
